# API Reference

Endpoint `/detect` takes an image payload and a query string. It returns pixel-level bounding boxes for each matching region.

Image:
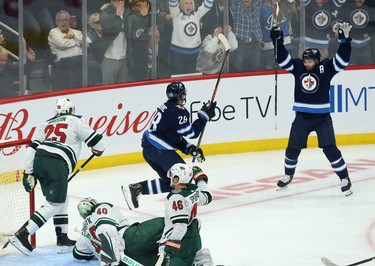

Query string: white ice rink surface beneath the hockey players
[0,145,375,266]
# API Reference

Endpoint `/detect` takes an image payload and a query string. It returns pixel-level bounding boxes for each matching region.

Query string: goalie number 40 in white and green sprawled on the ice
[73,198,164,266]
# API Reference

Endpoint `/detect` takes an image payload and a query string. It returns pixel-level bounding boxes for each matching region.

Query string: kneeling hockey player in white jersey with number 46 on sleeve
[159,163,213,266]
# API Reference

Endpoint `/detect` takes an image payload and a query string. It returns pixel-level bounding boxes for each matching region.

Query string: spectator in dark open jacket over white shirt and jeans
[97,0,129,84]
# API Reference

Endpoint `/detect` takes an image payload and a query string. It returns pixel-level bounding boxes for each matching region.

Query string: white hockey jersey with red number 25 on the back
[25,114,104,174]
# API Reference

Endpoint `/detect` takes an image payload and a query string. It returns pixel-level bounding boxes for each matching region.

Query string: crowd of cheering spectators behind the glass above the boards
[0,0,375,95]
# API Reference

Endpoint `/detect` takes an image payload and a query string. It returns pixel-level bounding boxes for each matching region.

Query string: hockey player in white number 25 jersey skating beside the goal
[9,98,104,255]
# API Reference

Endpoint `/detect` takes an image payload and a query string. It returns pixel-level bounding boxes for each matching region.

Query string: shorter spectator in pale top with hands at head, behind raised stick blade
[197,25,238,74]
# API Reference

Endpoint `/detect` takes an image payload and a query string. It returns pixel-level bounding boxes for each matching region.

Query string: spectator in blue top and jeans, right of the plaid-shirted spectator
[260,0,294,69]
